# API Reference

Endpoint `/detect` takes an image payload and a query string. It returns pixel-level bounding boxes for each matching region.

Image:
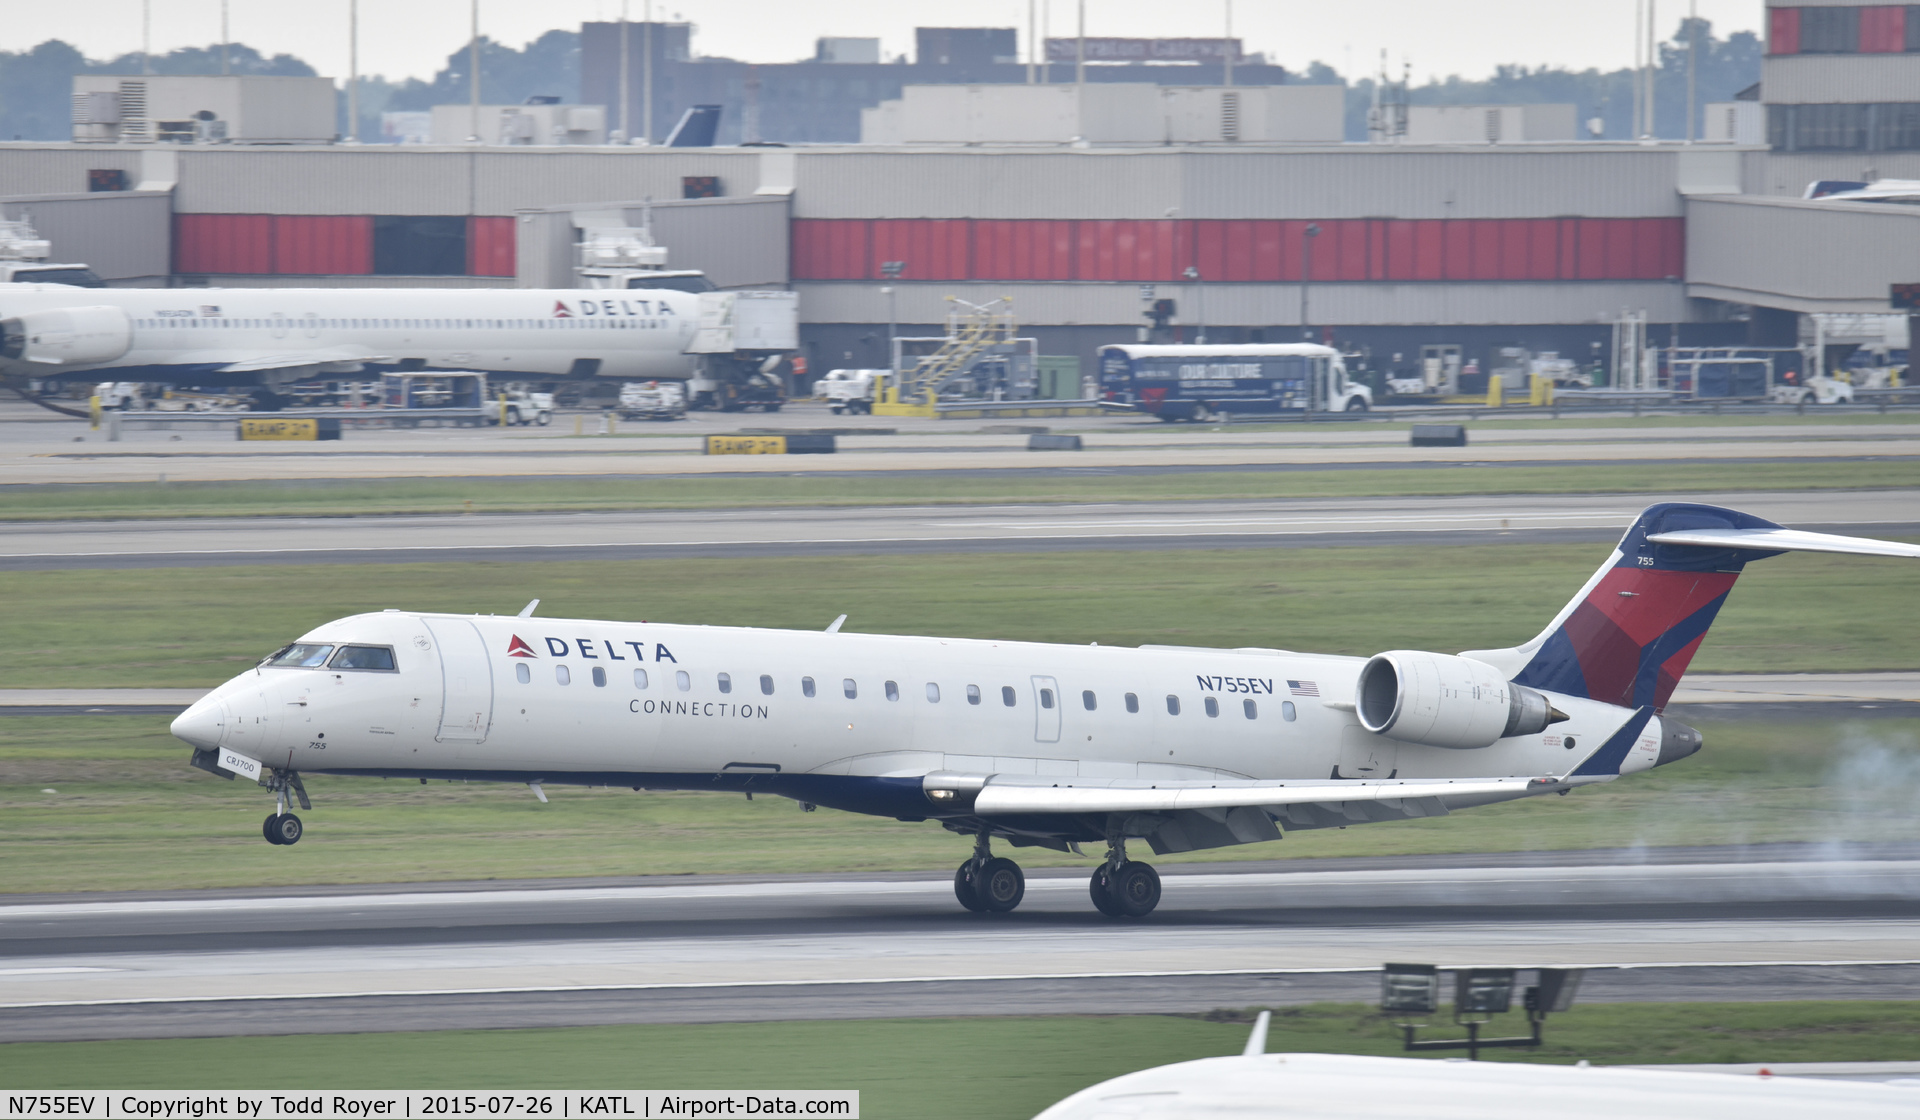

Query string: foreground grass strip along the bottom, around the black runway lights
[0,1001,1920,1120]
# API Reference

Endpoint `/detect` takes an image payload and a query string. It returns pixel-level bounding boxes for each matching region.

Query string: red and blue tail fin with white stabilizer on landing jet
[1463,501,1920,711]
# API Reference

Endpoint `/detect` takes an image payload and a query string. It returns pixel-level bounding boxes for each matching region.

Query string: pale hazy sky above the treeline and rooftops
[0,0,1763,81]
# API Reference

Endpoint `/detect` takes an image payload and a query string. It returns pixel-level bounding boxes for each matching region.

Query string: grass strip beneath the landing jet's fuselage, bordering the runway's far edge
[0,717,1920,895]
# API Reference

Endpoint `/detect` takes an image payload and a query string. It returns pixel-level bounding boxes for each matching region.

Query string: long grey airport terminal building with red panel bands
[0,2,1920,384]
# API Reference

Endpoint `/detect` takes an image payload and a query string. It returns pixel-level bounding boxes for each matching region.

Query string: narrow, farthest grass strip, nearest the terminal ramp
[0,455,1920,521]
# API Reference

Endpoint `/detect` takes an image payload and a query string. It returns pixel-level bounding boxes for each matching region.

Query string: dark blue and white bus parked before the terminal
[1100,342,1373,421]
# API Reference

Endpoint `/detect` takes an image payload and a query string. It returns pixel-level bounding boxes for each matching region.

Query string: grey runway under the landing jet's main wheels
[0,847,1920,1039]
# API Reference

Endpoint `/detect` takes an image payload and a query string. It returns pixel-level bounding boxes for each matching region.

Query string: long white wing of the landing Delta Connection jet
[967,774,1559,816]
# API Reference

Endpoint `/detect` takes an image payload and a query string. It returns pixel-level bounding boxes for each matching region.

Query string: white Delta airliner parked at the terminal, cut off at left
[0,284,701,388]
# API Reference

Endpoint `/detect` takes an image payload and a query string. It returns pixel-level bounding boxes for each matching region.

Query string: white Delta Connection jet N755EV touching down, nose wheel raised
[173,503,1920,916]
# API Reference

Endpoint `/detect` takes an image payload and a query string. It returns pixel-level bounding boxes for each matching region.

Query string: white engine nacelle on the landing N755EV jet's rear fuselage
[1354,649,1567,749]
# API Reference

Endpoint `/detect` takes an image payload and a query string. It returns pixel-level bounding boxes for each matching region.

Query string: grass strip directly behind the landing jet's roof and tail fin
[0,544,1920,688]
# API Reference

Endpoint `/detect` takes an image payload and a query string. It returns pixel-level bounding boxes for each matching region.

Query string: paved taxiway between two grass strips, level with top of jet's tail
[0,490,1920,571]
